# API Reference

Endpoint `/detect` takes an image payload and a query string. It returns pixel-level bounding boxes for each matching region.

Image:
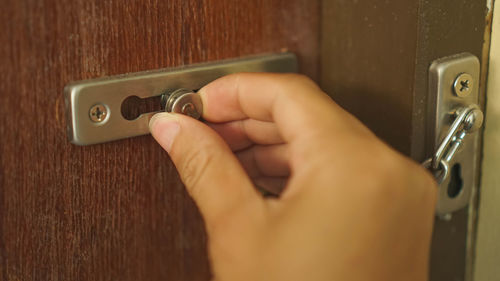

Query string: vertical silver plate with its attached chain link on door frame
[423,53,483,215]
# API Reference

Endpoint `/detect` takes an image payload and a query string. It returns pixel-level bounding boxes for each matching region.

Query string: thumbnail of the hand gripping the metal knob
[149,112,181,153]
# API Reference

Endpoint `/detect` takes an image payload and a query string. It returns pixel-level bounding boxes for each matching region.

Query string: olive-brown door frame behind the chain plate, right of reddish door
[320,0,492,281]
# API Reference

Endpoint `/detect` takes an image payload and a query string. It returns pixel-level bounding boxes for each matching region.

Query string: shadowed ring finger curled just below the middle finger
[236,144,290,178]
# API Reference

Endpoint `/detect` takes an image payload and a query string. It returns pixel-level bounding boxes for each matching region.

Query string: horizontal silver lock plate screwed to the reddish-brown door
[64,53,298,145]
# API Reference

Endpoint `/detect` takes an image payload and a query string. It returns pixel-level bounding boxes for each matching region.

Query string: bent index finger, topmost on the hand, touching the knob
[199,73,344,141]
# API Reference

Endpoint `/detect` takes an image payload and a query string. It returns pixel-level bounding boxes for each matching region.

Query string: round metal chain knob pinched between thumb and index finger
[161,89,203,119]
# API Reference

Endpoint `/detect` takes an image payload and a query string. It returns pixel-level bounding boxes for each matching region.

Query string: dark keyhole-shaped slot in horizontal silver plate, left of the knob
[121,96,162,120]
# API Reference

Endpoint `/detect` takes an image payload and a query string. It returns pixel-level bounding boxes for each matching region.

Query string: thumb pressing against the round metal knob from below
[149,113,262,226]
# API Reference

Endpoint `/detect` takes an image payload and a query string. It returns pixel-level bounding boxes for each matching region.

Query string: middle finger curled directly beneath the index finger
[208,119,284,151]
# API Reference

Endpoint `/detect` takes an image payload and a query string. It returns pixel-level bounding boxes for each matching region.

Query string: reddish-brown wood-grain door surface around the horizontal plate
[0,0,319,281]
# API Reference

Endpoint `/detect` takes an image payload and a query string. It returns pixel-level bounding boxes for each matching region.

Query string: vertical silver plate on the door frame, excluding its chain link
[427,53,480,216]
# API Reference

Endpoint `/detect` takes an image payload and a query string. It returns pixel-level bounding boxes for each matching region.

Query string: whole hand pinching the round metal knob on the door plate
[150,73,437,281]
